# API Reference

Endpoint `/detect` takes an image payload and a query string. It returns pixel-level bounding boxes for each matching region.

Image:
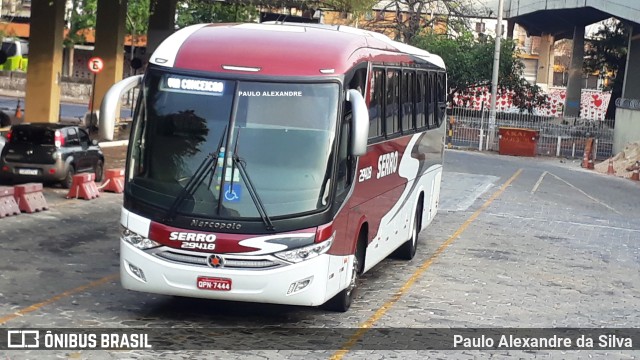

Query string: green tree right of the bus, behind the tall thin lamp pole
[414,31,547,112]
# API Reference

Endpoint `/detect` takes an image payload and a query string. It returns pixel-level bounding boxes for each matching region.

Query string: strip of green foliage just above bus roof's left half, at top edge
[176,0,258,28]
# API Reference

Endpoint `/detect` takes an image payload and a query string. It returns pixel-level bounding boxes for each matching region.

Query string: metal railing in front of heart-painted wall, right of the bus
[447,107,613,159]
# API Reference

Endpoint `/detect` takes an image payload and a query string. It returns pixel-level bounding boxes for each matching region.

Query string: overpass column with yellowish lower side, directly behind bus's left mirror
[93,0,127,110]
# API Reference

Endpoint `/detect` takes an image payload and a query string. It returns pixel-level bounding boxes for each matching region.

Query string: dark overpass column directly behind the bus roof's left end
[146,0,178,59]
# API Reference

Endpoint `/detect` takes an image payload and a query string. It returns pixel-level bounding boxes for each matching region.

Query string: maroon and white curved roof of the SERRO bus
[150,23,445,76]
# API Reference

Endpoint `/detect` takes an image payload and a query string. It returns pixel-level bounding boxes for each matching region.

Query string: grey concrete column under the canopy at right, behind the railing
[564,25,584,117]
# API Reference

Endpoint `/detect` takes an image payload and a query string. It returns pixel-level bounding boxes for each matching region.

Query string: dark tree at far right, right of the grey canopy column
[584,19,629,119]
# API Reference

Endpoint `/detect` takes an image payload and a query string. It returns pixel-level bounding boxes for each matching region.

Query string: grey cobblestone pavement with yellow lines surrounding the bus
[0,151,640,360]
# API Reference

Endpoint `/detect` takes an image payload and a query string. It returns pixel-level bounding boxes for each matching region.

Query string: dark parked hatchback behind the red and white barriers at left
[0,124,104,188]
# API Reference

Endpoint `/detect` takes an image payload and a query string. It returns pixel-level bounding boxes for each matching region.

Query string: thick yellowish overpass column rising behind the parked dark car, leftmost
[24,0,65,122]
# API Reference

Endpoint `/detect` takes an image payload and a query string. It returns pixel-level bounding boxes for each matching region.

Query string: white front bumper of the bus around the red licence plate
[120,240,348,306]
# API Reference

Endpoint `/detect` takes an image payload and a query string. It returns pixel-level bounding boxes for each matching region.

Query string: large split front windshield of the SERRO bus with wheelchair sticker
[128,71,339,219]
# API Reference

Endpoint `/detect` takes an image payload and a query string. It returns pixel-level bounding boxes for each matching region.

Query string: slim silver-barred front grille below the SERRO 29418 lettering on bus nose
[154,251,285,270]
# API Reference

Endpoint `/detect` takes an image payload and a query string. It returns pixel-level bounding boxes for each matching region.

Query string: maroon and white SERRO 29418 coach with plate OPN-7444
[99,23,446,311]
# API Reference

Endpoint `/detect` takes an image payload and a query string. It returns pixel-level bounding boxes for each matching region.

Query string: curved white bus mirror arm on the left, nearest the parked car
[98,75,142,140]
